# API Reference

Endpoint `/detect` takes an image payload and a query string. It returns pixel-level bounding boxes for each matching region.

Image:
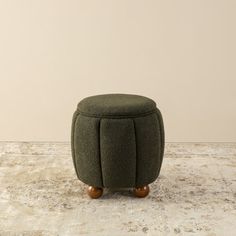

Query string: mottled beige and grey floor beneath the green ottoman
[0,142,236,236]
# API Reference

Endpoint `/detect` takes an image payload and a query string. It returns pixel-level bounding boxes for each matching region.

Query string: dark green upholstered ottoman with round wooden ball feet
[71,94,164,198]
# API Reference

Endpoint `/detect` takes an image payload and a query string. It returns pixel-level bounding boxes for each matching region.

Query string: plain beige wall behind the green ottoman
[0,0,236,142]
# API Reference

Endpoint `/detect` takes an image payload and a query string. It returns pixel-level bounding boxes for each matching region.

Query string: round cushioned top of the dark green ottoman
[77,94,156,118]
